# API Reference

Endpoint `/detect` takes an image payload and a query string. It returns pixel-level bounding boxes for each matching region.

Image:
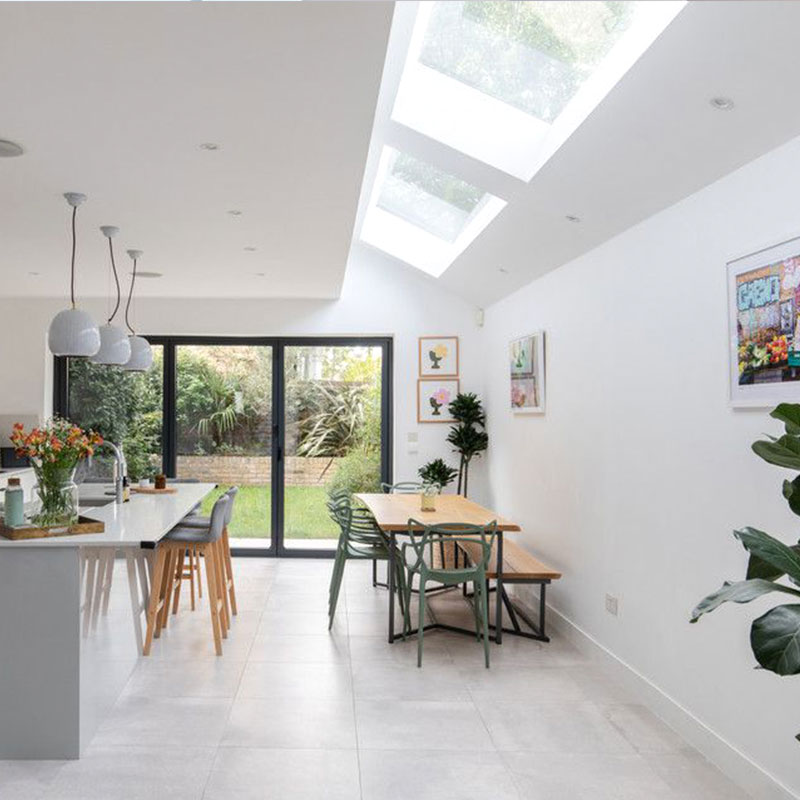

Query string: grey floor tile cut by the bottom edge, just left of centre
[203,747,361,800]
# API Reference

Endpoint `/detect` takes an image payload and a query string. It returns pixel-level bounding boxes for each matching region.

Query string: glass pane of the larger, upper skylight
[419,0,634,122]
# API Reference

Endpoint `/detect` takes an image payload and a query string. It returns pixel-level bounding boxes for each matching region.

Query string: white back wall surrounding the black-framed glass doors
[0,250,483,493]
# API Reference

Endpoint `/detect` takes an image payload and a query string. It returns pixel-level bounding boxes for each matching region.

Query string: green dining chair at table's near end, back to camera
[400,519,497,669]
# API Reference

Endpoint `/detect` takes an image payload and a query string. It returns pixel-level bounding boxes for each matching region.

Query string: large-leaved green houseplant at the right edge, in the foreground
[691,403,800,739]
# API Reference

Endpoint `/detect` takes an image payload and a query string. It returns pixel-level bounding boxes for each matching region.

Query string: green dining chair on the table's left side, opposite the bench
[328,493,407,630]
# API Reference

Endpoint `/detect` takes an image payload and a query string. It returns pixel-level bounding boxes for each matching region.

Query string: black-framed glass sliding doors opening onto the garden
[55,336,392,557]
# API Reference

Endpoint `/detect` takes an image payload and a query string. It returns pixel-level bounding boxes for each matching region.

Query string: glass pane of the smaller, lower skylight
[377,151,487,242]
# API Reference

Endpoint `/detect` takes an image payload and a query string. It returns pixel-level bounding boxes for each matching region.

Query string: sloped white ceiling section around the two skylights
[359,0,800,306]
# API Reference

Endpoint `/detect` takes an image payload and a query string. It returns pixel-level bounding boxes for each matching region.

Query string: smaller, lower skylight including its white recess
[361,147,505,276]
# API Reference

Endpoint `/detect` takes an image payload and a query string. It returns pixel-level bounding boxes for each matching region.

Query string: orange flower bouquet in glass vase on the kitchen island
[11,417,103,526]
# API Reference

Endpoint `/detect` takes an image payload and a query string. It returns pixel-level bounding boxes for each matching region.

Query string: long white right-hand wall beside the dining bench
[484,134,800,797]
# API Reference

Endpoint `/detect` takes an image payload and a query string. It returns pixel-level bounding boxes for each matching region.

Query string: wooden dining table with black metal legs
[354,493,521,644]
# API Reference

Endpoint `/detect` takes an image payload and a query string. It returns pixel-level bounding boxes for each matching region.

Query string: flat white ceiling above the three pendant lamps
[0,2,392,297]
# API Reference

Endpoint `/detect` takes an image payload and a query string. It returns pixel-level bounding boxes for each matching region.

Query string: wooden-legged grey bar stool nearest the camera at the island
[142,495,231,656]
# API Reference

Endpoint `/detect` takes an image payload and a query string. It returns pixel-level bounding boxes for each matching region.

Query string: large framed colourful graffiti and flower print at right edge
[726,233,800,408]
